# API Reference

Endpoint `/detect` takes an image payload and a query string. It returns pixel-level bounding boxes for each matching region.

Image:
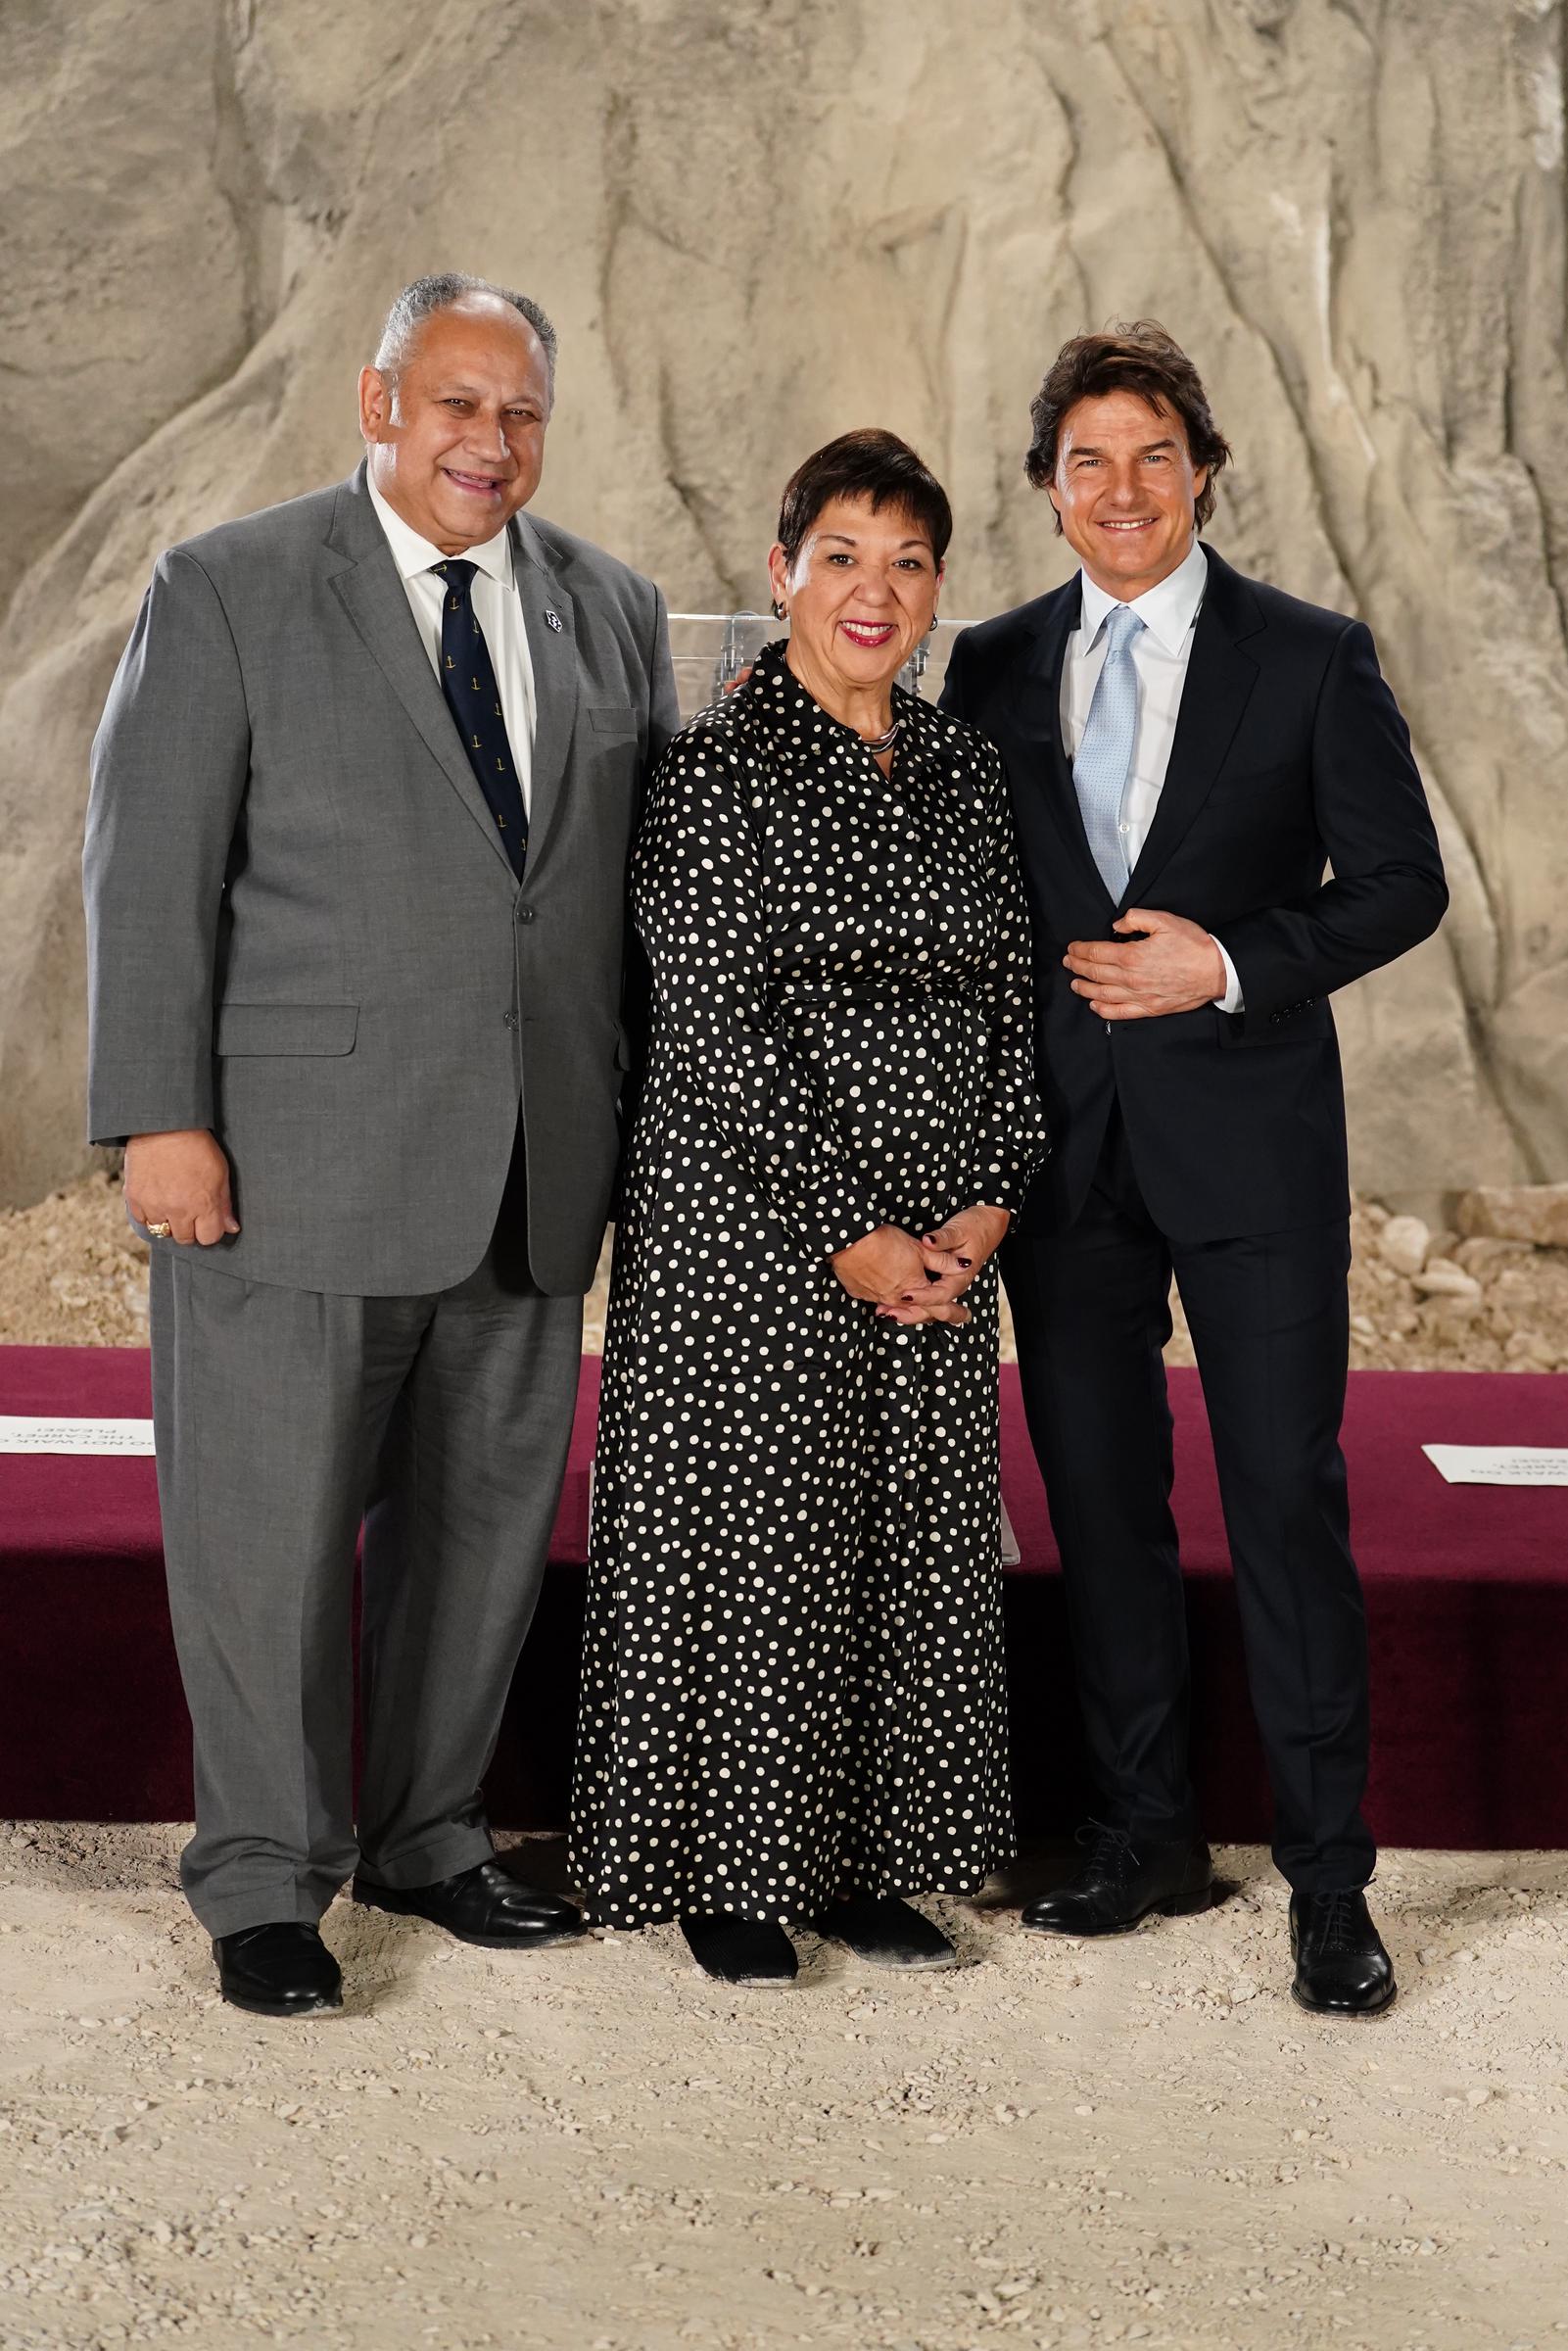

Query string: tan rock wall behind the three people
[0,0,1568,1201]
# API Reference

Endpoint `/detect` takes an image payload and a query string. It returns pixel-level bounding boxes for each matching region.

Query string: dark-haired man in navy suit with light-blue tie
[943,322,1449,2015]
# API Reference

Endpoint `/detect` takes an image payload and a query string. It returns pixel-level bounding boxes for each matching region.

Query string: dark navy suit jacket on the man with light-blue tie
[943,548,1449,1241]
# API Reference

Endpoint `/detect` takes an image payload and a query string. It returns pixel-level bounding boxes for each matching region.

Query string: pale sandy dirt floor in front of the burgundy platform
[0,1824,1568,2351]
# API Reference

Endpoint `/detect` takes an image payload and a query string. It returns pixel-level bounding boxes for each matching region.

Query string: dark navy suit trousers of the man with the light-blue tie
[1002,1110,1375,1893]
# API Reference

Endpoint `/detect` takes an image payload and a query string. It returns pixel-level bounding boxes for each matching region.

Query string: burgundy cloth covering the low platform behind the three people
[0,1347,1568,1846]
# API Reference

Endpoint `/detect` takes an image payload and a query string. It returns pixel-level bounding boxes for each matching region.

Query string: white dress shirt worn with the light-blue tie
[1063,531,1241,1013]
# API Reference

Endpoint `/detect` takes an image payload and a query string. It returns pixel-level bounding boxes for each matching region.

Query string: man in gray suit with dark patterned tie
[84,275,677,2015]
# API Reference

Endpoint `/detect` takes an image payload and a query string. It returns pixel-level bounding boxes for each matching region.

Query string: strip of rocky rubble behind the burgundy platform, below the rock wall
[0,1174,1568,1370]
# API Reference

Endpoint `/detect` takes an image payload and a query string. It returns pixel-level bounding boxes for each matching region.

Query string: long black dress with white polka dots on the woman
[571,647,1044,1928]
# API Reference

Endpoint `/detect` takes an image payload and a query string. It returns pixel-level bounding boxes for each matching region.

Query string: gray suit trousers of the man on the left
[151,1171,583,1935]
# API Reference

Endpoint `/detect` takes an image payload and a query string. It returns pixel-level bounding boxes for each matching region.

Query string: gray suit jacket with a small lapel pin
[84,468,677,1295]
